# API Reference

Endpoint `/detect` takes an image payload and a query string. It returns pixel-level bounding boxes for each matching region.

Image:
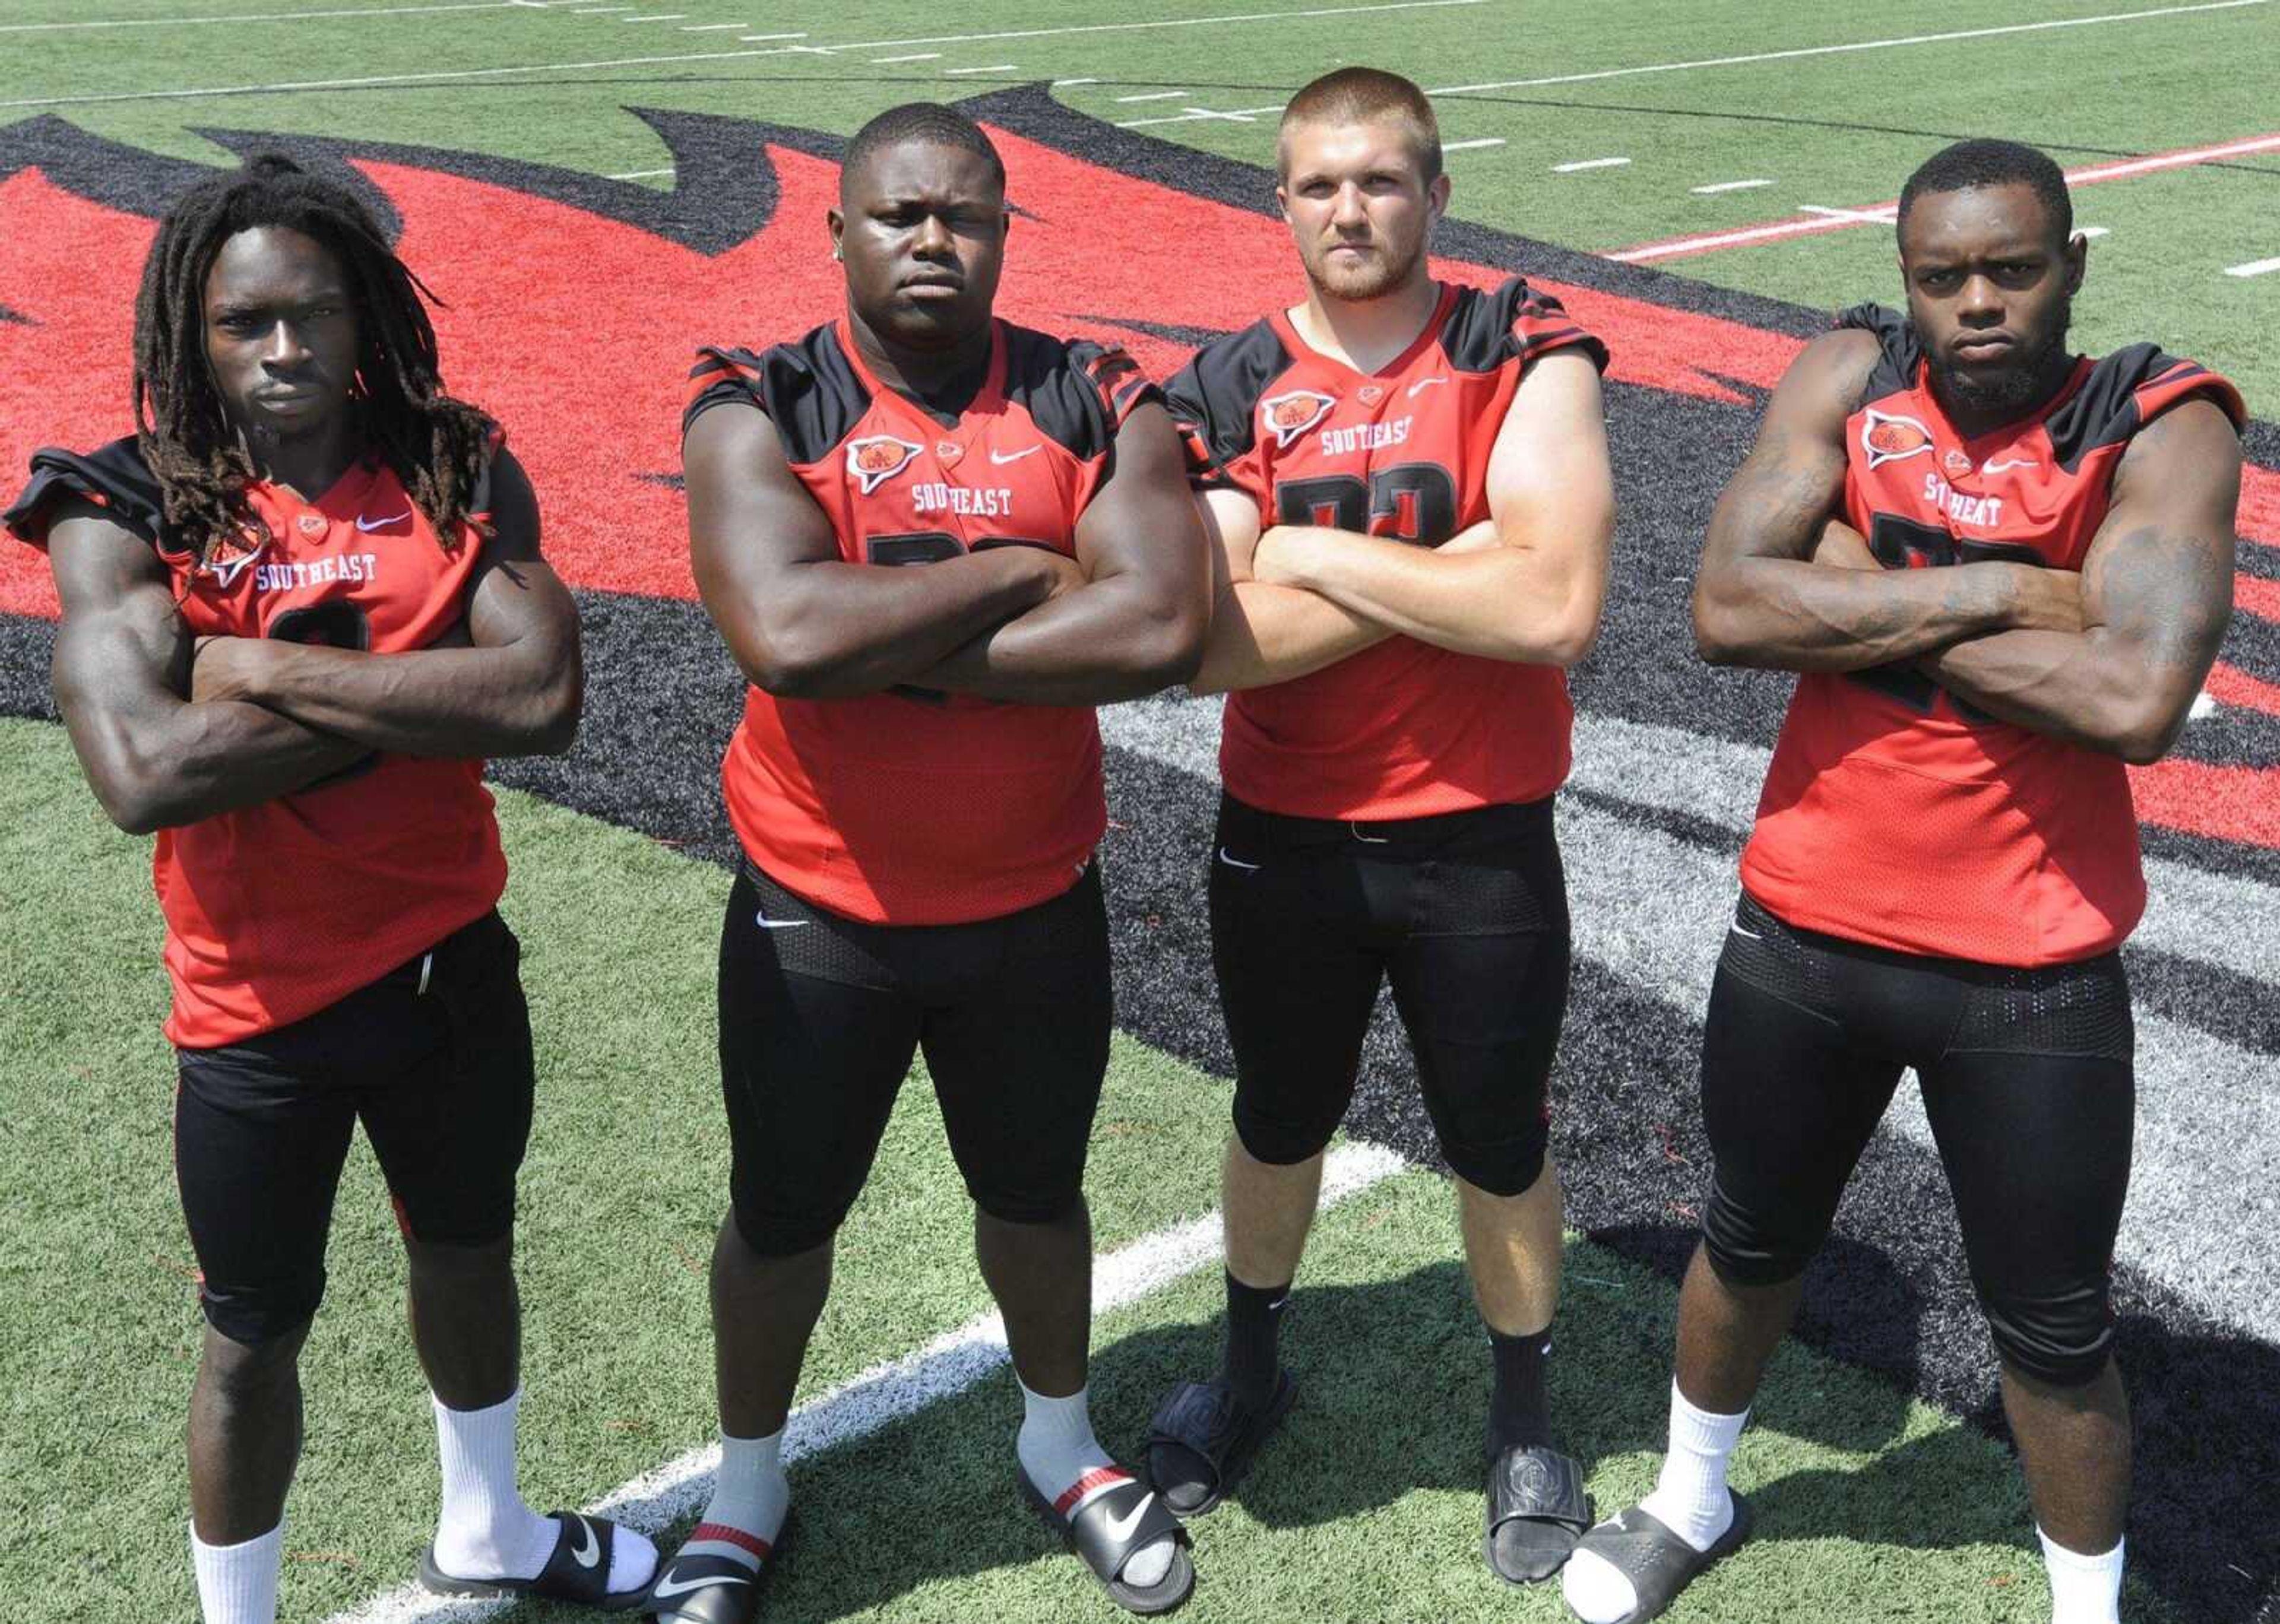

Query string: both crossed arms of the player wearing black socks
[1190,351,1614,693]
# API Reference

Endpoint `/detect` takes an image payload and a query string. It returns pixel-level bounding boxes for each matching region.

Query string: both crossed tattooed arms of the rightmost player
[1694,331,2241,764]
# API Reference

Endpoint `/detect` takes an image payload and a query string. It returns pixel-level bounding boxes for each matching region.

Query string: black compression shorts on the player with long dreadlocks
[173,912,534,1343]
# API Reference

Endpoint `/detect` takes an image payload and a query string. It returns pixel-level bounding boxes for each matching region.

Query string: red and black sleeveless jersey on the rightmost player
[1742,306,2246,967]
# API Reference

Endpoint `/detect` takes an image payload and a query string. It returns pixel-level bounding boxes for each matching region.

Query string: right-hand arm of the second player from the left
[917,401,1211,705]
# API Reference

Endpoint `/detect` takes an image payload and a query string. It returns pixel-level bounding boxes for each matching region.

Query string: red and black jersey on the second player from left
[682,319,1156,924]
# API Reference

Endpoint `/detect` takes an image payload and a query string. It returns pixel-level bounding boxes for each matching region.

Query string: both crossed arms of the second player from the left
[682,401,1211,705]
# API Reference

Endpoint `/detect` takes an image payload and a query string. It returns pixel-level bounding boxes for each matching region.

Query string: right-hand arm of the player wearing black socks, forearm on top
[1254,354,1614,666]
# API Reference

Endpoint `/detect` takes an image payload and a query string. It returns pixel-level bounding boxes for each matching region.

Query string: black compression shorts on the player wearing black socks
[1211,796,1569,1195]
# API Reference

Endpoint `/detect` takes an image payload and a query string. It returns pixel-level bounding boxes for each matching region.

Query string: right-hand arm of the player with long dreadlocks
[192,452,584,757]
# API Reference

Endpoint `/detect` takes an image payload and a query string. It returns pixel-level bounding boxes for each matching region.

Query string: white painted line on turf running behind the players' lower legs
[326,1143,1409,1624]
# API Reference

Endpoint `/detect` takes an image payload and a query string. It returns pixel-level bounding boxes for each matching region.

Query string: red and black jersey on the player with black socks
[1165,276,1607,819]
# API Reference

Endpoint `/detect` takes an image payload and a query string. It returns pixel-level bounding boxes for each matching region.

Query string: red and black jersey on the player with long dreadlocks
[7,440,506,1049]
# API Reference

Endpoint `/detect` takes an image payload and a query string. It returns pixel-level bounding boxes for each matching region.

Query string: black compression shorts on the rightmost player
[1703,894,2136,1385]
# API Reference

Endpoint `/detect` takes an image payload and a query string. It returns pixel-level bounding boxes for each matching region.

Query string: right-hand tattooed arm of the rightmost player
[1917,399,2241,764]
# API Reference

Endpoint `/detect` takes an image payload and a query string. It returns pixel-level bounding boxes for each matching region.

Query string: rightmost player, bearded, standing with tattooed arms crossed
[1564,141,2244,1624]
